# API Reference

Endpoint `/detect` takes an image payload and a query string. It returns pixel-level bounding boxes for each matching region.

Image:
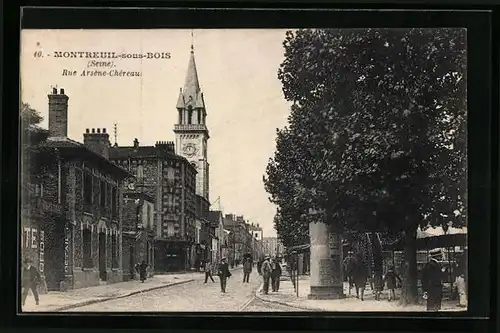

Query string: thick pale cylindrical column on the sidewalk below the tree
[308,222,344,299]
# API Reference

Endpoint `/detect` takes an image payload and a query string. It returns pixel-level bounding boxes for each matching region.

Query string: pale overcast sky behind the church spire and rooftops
[21,29,290,237]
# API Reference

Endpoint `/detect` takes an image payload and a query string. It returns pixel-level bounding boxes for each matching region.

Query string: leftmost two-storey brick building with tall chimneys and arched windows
[21,89,131,290]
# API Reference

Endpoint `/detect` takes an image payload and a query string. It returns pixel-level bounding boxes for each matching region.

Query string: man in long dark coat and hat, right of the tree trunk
[422,250,443,311]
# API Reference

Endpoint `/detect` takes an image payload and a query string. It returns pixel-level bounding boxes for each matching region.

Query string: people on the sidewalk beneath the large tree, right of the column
[343,250,467,311]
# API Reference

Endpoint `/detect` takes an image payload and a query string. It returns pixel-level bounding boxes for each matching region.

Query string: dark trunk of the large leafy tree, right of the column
[400,228,418,305]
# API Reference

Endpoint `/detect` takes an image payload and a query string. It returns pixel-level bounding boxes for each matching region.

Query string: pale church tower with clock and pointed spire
[174,39,210,201]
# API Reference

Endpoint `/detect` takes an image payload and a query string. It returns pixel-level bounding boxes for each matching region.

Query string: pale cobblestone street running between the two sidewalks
[65,269,297,312]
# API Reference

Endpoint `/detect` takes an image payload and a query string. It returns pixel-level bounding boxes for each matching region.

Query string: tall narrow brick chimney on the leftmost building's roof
[48,88,69,137]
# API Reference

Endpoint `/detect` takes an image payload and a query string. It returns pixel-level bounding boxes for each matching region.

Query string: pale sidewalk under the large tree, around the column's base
[255,276,466,312]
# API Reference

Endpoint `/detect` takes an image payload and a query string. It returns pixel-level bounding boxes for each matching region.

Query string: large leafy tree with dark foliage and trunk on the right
[264,29,466,303]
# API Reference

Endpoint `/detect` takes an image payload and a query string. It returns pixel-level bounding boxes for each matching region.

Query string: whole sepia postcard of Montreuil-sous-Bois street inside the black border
[18,28,468,312]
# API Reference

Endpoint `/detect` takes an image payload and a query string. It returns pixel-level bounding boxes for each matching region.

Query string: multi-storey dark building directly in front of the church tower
[110,139,196,272]
